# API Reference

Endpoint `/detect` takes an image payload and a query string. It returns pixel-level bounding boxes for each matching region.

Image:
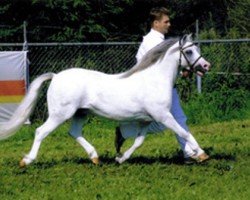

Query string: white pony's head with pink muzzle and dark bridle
[178,34,210,76]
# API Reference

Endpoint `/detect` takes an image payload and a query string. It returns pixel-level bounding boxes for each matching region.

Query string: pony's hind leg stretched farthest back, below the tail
[19,117,63,167]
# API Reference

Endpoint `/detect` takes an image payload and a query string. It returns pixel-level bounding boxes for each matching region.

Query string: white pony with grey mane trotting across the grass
[0,36,210,167]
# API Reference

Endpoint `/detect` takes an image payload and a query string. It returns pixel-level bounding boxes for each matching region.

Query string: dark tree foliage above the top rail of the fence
[0,0,250,42]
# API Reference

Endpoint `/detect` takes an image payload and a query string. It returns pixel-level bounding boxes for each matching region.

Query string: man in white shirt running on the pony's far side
[115,7,209,164]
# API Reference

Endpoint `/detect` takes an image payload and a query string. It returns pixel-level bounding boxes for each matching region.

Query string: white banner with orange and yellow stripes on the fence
[0,51,27,123]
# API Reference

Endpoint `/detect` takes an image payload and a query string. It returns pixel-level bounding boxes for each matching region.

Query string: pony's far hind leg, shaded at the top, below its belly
[69,111,99,165]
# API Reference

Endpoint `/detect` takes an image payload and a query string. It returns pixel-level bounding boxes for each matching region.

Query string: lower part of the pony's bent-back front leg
[115,135,145,164]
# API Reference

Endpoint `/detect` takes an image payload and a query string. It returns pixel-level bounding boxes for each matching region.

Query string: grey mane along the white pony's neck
[120,38,179,78]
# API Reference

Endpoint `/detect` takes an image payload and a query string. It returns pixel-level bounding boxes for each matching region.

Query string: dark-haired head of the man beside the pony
[149,7,171,34]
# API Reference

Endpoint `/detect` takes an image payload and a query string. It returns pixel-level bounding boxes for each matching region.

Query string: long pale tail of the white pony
[0,73,55,140]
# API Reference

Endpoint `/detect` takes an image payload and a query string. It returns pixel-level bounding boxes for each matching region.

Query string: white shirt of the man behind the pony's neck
[135,29,164,62]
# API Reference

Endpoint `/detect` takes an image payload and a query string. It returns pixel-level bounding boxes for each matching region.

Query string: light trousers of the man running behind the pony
[120,88,204,157]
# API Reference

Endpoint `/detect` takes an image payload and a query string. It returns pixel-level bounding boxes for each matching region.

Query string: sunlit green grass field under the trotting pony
[0,120,250,200]
